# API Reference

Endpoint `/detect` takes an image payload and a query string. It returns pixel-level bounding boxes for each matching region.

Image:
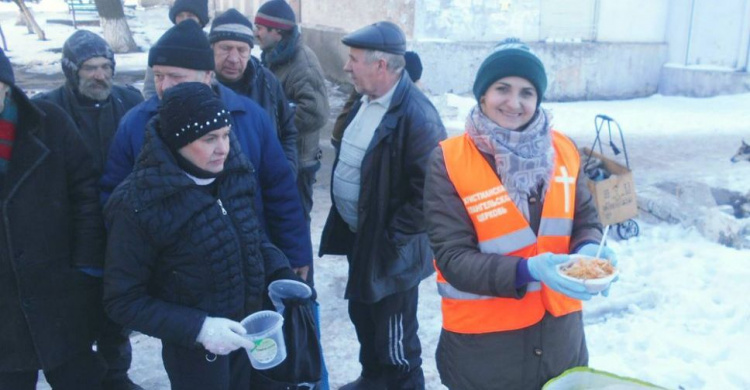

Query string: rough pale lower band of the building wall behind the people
[303,28,667,101]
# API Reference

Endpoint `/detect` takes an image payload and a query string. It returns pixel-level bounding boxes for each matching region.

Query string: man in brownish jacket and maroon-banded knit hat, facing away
[255,0,330,256]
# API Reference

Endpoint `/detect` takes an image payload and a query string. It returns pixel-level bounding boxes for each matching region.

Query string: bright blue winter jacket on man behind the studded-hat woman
[100,80,312,267]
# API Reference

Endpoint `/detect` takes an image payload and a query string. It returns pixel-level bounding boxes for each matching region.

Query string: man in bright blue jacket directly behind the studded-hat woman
[100,20,312,296]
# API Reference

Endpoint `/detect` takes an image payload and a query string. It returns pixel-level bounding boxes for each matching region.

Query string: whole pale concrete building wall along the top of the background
[210,0,750,100]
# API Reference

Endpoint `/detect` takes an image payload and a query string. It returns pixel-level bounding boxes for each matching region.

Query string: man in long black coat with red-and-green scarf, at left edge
[0,50,105,390]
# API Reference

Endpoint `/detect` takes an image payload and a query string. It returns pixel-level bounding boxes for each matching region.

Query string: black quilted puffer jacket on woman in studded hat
[104,120,289,347]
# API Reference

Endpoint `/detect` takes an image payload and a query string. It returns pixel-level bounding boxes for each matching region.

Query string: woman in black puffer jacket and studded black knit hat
[104,83,302,390]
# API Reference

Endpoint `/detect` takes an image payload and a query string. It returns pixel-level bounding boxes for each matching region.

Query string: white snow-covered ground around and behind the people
[0,0,750,389]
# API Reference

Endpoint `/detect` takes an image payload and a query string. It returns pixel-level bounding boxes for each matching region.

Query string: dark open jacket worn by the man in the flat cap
[319,72,446,303]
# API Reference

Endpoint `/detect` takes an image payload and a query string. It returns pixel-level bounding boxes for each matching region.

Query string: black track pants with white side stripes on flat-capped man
[349,287,424,389]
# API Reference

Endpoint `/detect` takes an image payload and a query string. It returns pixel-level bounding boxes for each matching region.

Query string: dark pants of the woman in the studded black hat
[161,342,251,390]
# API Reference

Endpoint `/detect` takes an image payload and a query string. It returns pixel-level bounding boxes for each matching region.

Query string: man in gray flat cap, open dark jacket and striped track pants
[320,22,446,390]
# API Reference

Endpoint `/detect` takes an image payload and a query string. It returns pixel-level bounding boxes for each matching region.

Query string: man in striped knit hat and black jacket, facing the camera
[208,8,300,178]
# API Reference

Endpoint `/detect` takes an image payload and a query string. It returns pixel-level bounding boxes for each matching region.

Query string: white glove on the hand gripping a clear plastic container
[196,317,253,355]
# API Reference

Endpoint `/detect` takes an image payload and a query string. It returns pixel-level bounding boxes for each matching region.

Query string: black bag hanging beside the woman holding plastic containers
[251,299,322,390]
